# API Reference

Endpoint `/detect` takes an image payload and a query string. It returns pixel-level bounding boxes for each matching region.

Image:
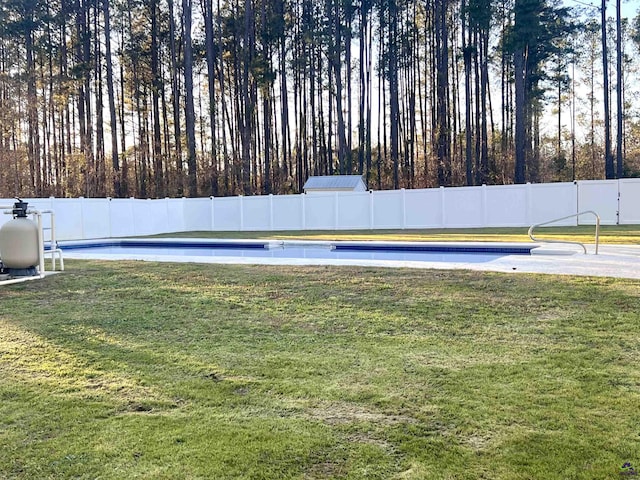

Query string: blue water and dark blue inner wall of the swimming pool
[61,239,535,263]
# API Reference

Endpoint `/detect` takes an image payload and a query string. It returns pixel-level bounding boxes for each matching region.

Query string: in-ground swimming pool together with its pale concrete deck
[36,238,640,284]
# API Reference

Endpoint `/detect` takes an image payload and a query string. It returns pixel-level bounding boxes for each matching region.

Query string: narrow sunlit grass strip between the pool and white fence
[150,225,640,245]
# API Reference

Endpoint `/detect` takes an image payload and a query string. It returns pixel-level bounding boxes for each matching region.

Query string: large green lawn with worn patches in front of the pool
[0,261,640,480]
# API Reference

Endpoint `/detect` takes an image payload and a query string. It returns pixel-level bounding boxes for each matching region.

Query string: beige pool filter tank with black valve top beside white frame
[0,199,40,277]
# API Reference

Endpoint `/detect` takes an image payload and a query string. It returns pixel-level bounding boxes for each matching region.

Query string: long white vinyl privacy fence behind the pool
[0,179,640,240]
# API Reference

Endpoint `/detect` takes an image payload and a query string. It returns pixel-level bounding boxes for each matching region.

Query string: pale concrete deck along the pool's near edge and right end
[55,239,640,279]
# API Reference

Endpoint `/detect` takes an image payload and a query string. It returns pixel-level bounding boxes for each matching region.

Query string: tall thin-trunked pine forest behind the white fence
[0,0,640,197]
